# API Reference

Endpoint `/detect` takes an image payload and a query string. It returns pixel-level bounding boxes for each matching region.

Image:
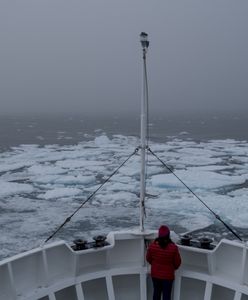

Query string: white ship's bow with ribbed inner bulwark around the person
[0,231,248,300]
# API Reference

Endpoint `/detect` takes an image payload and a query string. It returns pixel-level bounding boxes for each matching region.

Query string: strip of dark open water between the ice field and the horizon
[0,114,248,151]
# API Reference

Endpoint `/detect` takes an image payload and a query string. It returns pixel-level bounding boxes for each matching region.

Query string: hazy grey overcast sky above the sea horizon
[0,0,248,114]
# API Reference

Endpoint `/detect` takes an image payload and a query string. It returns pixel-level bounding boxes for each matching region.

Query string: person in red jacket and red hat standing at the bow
[146,225,181,300]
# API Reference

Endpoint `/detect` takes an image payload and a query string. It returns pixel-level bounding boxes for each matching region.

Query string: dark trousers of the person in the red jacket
[152,278,173,300]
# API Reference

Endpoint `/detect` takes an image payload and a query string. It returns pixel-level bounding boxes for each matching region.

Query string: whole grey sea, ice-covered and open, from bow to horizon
[0,115,248,258]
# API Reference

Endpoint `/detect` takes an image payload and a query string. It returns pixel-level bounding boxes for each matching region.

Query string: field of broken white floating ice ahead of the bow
[0,131,248,257]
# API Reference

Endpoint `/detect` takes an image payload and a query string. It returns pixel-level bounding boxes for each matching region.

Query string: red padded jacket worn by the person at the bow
[146,240,181,280]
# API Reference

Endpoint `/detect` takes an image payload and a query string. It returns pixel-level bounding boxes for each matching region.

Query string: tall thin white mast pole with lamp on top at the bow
[140,32,149,232]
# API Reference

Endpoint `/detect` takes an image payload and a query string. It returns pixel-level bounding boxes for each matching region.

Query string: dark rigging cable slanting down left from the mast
[44,147,139,244]
